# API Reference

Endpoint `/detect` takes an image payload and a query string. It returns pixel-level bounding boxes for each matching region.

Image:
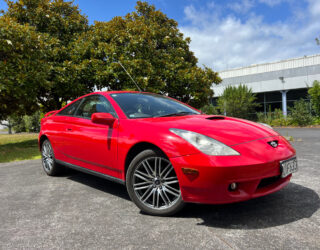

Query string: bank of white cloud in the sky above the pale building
[180,0,320,70]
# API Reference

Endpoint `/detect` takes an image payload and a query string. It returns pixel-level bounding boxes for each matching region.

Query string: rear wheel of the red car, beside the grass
[41,139,63,176]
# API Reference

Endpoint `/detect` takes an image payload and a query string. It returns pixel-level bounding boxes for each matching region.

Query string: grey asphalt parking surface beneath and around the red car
[0,128,320,249]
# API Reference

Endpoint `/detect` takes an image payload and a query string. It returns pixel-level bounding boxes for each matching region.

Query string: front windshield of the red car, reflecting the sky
[111,93,199,119]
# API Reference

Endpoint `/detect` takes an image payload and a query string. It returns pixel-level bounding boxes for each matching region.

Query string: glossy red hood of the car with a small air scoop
[140,115,279,146]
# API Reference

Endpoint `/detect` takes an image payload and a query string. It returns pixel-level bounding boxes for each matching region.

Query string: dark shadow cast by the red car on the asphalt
[65,170,320,229]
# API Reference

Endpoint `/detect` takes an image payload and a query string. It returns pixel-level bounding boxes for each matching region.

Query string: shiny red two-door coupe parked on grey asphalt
[39,91,297,215]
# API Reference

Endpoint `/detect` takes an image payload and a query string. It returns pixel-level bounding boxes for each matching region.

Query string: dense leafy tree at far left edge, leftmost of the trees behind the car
[0,16,54,121]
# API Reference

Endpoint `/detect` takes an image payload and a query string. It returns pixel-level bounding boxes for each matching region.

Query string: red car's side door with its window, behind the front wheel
[60,94,121,177]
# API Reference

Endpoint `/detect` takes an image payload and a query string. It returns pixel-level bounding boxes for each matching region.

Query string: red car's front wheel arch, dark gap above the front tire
[124,141,169,178]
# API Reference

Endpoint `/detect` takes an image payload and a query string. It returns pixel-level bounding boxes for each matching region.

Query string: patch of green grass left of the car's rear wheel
[0,133,41,163]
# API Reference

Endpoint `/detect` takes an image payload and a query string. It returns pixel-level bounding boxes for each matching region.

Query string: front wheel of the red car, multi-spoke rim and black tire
[126,149,185,216]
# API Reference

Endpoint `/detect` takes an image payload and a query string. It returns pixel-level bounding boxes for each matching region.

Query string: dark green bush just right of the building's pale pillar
[289,99,313,126]
